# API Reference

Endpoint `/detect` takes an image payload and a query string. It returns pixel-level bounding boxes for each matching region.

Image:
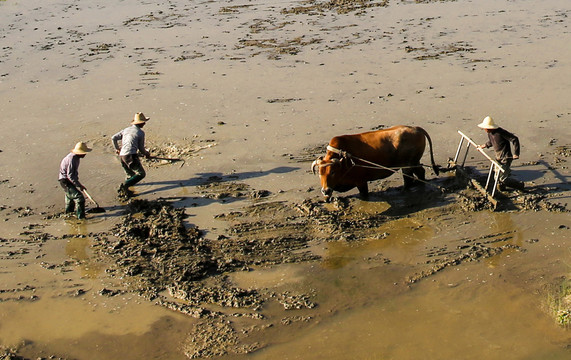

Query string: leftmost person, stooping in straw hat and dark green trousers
[58,142,91,220]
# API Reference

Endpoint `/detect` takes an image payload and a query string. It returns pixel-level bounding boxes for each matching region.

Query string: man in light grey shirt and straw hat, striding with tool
[111,112,151,197]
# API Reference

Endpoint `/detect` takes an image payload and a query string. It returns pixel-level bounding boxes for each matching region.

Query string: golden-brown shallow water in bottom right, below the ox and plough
[247,210,571,359]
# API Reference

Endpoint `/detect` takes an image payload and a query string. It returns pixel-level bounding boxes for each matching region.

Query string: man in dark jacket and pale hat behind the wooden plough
[478,116,519,189]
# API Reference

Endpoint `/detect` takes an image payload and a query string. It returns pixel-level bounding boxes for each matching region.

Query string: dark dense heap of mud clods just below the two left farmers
[96,200,217,299]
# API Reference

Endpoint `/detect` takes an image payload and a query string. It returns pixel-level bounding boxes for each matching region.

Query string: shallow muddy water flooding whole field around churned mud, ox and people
[0,0,571,359]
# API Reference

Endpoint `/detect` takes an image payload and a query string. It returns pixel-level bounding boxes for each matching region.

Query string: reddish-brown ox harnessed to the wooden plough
[311,125,438,198]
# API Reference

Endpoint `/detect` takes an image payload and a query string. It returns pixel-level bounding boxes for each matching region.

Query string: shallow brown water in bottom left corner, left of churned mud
[0,215,197,359]
